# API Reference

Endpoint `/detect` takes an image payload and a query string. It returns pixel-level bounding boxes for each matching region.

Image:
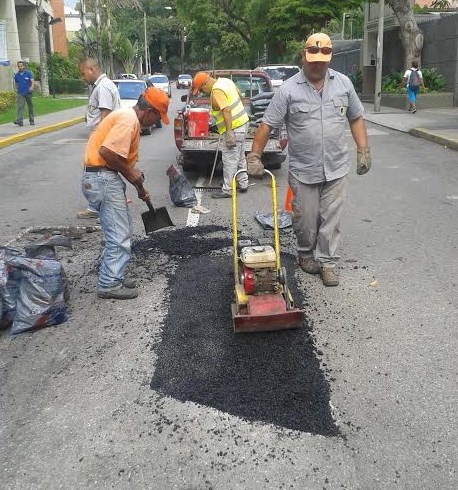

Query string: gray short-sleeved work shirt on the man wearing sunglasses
[262,68,364,184]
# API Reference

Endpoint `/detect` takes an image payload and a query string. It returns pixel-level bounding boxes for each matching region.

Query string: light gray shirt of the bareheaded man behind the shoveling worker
[86,73,121,131]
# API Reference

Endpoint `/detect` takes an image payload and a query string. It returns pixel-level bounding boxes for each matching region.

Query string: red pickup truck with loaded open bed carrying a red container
[174,70,288,170]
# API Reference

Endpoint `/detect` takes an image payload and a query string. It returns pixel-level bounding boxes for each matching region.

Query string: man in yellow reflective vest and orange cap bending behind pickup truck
[192,71,249,199]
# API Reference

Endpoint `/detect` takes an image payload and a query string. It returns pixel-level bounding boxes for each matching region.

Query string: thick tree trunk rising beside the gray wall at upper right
[386,0,423,68]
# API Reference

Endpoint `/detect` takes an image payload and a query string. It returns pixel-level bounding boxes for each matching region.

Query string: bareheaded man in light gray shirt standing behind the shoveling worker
[76,58,121,219]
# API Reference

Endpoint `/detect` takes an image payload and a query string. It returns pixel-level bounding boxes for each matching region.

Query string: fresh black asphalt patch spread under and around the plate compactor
[133,226,338,436]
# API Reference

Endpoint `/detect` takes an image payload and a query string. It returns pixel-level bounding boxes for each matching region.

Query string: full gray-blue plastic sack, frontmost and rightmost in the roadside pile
[7,257,68,334]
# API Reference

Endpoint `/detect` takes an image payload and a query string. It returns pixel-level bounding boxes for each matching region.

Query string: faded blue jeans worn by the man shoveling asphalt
[81,171,132,291]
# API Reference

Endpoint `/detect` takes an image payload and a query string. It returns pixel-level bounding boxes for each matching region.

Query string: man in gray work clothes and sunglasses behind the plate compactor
[247,33,371,286]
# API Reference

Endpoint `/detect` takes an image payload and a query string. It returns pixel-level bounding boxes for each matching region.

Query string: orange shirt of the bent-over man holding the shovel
[84,108,140,168]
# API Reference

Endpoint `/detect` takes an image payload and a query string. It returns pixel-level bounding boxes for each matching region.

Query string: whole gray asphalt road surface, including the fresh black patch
[0,90,458,490]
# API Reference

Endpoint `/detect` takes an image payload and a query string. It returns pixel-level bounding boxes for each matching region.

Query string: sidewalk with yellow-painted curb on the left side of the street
[0,105,86,148]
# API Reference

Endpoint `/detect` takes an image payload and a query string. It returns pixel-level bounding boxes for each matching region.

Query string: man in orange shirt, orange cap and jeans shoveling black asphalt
[81,87,169,299]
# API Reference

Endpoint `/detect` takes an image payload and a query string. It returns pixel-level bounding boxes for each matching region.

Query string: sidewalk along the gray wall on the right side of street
[363,103,458,151]
